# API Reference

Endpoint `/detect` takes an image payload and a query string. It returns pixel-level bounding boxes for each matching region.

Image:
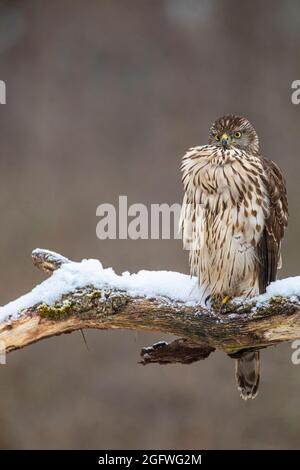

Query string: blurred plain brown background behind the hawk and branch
[0,0,300,449]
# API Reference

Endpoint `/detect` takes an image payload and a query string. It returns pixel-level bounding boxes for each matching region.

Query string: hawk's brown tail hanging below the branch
[235,351,260,400]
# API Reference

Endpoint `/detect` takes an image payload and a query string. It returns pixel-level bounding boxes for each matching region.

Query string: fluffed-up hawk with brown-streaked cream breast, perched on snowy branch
[180,115,288,399]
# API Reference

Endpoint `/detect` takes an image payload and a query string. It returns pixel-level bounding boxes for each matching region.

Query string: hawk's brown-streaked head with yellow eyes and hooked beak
[209,114,259,155]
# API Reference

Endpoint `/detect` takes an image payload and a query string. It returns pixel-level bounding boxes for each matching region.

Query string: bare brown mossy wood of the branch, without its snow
[0,250,300,364]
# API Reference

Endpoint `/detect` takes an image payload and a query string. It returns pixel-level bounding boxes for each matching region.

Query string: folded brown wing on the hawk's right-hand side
[257,158,288,293]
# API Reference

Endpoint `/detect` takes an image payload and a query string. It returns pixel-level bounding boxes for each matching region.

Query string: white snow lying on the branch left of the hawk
[0,255,201,323]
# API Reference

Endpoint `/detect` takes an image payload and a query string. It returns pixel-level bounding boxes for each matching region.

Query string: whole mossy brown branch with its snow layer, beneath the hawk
[0,249,300,364]
